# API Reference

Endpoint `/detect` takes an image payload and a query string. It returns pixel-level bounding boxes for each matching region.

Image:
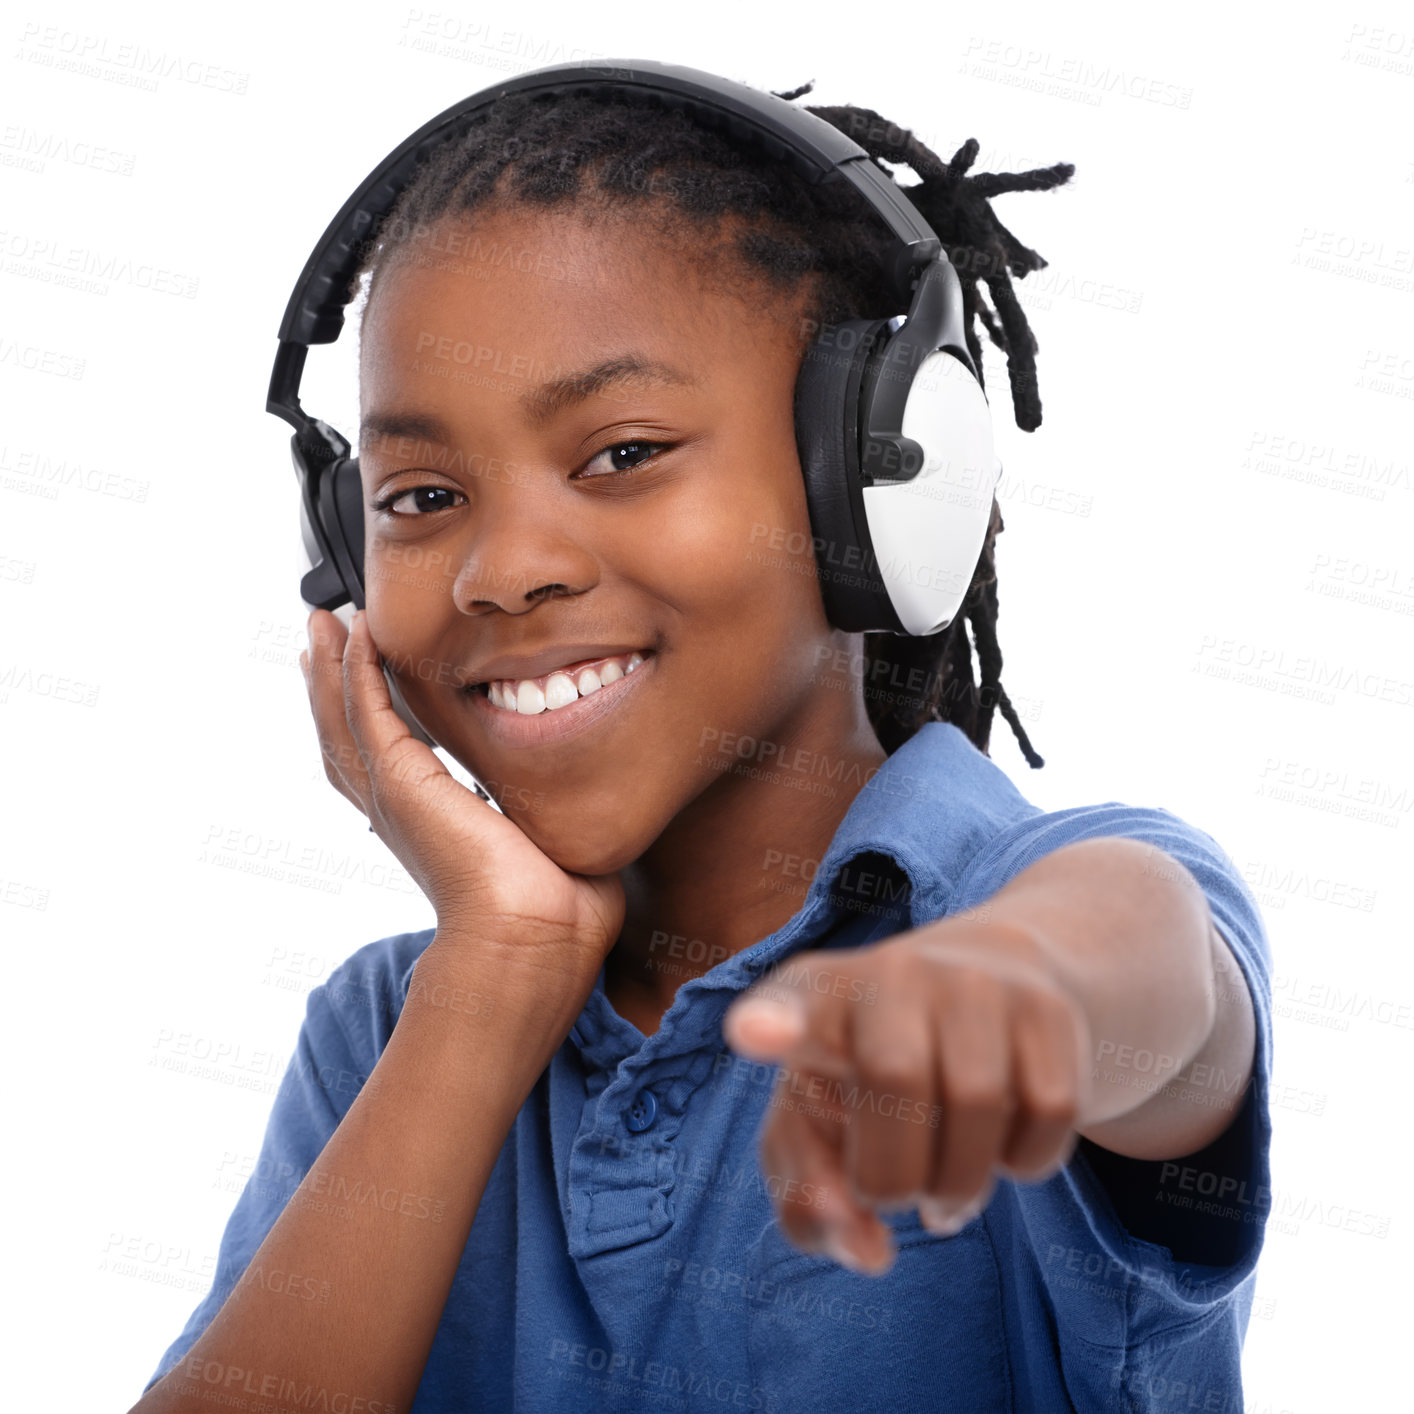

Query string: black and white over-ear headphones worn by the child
[266,59,1001,745]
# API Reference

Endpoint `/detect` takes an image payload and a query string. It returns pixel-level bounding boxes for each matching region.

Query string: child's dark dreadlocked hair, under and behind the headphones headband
[349,82,1075,766]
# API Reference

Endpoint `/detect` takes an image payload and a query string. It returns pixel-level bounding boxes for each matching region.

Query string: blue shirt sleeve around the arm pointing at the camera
[949,802,1271,1348]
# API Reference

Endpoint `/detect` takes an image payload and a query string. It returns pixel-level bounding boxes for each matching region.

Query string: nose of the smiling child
[452,485,598,615]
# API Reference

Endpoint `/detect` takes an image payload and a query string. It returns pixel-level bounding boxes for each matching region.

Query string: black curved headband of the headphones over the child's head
[266,59,942,430]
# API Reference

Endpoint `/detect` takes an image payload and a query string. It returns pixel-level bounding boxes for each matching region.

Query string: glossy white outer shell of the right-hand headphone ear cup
[863,349,1001,638]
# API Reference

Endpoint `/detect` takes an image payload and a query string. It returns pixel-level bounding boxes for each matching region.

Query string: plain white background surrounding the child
[0,0,1414,1414]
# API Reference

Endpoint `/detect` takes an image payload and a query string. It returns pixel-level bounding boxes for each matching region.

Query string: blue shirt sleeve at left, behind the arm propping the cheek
[143,945,390,1394]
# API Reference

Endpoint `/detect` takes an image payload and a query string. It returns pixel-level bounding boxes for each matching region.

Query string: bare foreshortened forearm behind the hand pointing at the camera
[967,839,1256,1158]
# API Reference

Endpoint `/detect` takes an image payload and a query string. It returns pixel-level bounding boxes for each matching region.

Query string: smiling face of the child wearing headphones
[359,211,860,874]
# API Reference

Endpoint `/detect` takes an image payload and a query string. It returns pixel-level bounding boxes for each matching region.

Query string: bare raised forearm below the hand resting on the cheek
[136,938,573,1414]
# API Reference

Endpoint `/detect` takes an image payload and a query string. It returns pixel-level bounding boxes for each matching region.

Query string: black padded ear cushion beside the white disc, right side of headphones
[795,320,894,632]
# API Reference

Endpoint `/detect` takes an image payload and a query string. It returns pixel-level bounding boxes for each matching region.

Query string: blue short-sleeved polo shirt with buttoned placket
[140,723,1271,1414]
